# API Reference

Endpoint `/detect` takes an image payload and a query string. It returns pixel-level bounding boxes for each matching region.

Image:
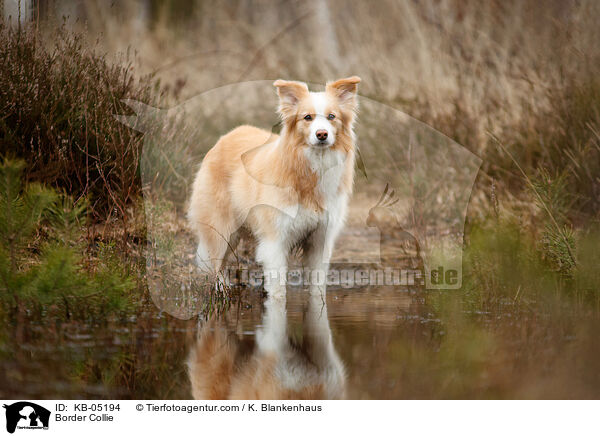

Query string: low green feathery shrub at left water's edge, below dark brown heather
[0,160,132,319]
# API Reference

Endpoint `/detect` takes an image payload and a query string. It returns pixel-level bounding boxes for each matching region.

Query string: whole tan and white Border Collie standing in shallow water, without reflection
[188,76,360,297]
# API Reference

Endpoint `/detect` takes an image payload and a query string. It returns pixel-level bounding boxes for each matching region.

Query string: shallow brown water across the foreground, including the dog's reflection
[0,287,600,399]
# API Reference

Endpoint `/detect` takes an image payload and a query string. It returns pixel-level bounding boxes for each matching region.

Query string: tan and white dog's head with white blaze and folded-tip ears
[274,76,360,148]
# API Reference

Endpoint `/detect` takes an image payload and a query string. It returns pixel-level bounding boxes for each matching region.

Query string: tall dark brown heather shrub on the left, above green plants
[0,24,159,225]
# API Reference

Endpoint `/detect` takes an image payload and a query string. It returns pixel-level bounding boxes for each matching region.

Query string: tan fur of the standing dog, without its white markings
[188,77,360,290]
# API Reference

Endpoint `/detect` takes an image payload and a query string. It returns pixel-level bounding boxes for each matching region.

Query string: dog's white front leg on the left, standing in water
[256,239,288,298]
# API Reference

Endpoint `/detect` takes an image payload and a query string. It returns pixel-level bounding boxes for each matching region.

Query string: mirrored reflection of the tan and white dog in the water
[188,296,346,400]
